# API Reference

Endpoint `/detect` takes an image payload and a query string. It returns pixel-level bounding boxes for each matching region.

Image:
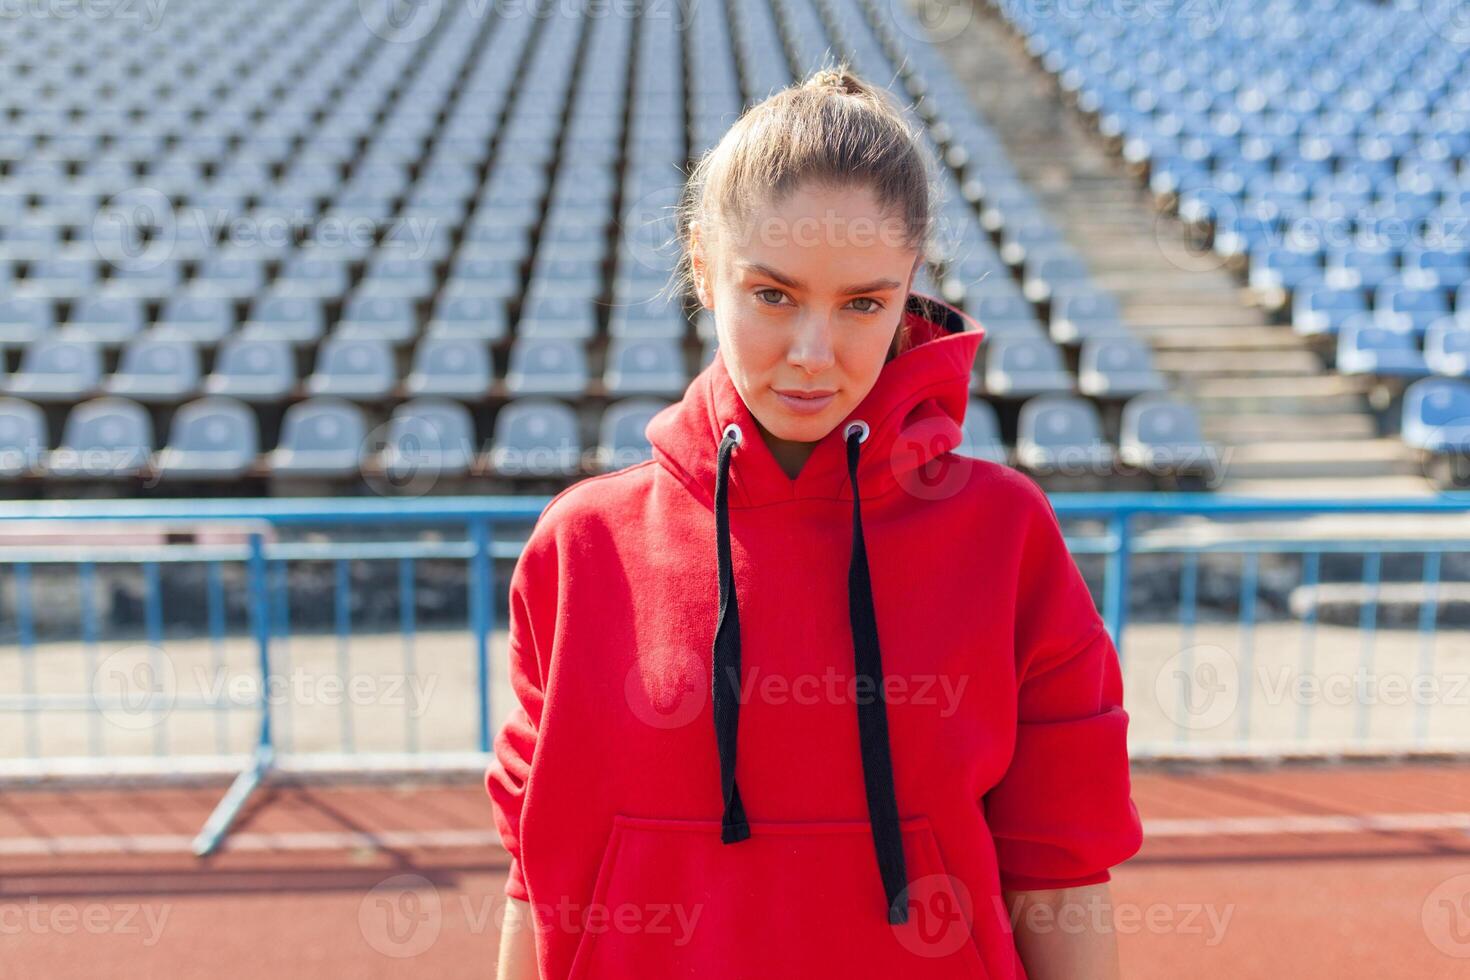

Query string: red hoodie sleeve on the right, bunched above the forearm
[983,478,1142,890]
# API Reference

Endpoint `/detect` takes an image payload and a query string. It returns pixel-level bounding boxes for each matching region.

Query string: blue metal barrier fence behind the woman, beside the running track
[0,494,1470,854]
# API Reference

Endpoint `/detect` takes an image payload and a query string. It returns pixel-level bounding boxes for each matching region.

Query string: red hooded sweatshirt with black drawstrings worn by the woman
[485,294,1142,980]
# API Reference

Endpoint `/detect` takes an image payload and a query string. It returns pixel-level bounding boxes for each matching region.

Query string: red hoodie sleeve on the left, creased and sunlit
[485,527,557,902]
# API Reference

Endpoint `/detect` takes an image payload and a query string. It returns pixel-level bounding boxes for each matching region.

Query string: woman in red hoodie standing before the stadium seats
[487,68,1141,980]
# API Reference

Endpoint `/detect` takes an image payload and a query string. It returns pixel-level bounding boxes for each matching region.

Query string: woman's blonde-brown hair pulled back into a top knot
[669,62,938,359]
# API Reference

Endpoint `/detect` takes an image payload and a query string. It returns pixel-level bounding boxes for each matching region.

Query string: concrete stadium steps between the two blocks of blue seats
[919,0,1433,497]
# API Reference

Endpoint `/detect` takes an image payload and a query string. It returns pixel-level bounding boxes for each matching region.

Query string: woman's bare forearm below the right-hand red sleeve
[1001,882,1123,980]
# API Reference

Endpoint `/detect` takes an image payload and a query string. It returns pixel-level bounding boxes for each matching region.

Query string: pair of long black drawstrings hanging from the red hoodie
[713,423,908,926]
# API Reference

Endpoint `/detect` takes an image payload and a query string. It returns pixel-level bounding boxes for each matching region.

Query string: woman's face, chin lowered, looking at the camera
[691,185,919,442]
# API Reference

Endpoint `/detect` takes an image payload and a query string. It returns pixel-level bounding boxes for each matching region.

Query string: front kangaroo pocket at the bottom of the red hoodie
[570,814,989,980]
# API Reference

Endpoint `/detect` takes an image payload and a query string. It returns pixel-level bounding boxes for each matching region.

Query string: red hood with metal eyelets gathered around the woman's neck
[647,292,985,507]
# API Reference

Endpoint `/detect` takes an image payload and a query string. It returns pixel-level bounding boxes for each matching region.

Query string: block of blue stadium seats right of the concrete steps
[994,0,1470,473]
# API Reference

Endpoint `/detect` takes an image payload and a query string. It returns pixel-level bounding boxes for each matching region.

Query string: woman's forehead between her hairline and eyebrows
[720,185,917,289]
